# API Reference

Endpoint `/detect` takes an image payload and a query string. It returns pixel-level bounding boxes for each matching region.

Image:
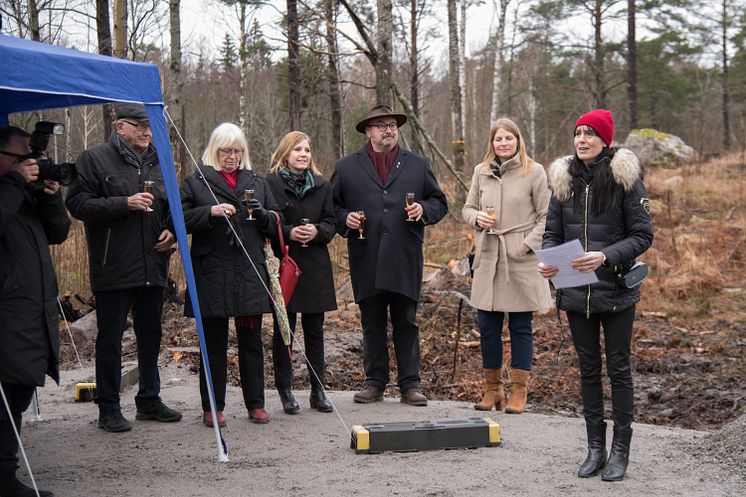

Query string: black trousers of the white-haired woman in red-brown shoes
[199,317,264,411]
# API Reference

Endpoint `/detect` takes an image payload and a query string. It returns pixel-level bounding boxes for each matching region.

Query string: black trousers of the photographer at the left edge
[0,382,34,474]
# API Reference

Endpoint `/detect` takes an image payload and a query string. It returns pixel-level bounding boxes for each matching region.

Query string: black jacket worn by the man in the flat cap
[65,142,171,292]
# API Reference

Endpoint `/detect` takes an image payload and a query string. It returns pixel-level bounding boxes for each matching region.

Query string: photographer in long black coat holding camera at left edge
[0,126,70,497]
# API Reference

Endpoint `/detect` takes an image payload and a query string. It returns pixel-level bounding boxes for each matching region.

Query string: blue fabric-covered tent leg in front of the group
[145,104,228,462]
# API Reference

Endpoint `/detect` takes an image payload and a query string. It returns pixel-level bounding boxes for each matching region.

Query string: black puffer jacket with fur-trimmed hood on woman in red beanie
[542,149,653,314]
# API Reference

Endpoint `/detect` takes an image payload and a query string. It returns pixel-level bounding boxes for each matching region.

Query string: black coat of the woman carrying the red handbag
[267,170,337,313]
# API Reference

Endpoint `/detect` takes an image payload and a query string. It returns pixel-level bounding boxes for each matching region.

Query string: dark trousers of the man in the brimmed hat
[359,292,420,392]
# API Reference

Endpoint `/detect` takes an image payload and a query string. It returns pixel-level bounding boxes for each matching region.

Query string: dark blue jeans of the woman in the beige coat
[477,310,534,371]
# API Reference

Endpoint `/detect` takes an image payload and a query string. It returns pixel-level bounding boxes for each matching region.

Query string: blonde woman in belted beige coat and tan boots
[462,118,551,414]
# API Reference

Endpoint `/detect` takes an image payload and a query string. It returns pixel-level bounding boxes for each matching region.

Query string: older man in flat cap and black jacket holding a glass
[66,103,181,432]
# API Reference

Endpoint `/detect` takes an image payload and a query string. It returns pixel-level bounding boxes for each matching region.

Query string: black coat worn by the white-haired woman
[181,166,277,318]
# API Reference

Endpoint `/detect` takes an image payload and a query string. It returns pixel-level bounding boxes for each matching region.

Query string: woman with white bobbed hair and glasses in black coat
[181,123,277,426]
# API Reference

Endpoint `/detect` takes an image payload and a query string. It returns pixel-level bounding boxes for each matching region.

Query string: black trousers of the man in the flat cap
[95,287,163,412]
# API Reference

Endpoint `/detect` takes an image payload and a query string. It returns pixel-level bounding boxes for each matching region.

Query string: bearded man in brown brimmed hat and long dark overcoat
[331,105,448,406]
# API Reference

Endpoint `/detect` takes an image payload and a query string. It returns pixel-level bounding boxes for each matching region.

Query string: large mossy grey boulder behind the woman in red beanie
[622,129,697,166]
